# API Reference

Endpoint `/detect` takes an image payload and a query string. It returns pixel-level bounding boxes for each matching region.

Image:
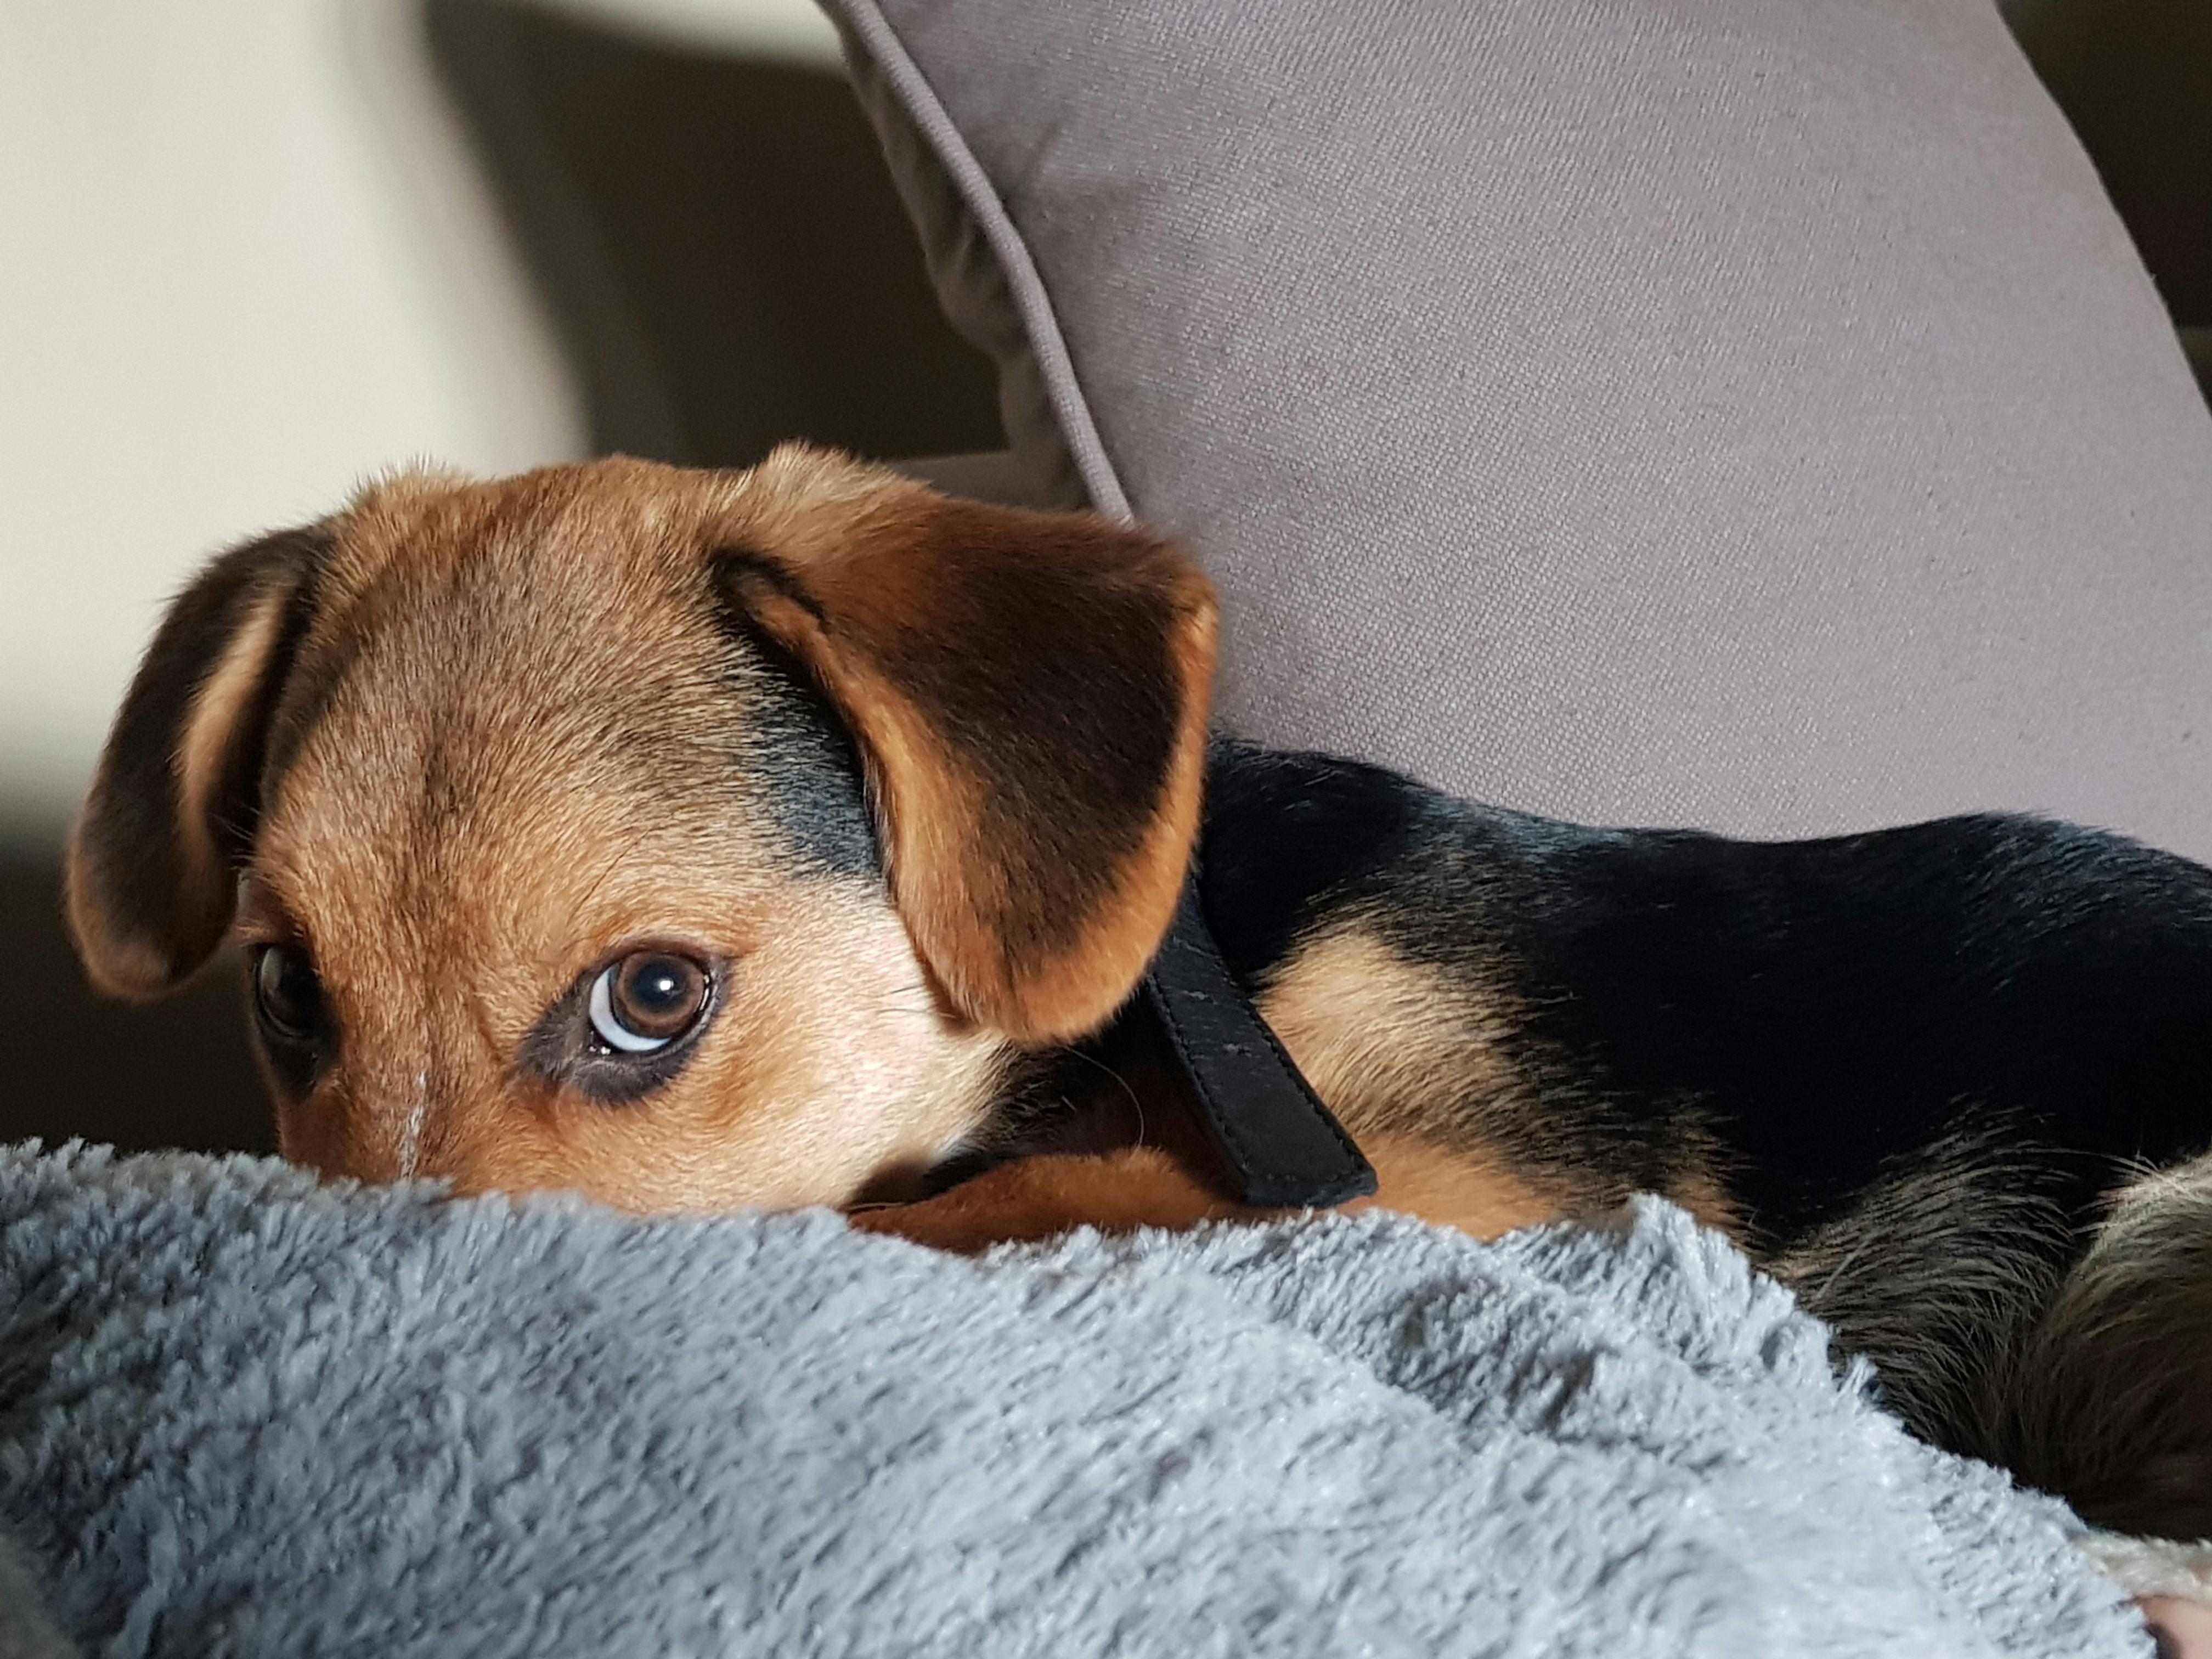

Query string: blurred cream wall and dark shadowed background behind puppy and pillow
[0,0,2212,1148]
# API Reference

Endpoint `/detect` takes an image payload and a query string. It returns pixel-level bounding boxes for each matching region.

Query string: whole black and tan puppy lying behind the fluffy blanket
[69,449,2212,1535]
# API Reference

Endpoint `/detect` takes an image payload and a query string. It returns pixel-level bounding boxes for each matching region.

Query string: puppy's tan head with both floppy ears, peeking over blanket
[69,449,1212,1210]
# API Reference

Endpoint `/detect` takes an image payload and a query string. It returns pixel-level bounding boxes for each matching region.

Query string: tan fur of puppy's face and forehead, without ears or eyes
[241,462,1005,1210]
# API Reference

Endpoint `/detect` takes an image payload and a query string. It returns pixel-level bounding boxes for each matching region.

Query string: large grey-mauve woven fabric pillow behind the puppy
[827,0,2212,856]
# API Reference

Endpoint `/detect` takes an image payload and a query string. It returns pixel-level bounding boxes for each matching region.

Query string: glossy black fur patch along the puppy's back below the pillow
[1201,743,2212,1250]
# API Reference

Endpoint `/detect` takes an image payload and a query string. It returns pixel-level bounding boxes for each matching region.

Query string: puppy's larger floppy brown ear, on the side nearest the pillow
[716,489,1215,1044]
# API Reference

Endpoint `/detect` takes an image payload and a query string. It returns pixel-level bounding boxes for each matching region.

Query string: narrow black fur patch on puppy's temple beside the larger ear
[712,549,883,878]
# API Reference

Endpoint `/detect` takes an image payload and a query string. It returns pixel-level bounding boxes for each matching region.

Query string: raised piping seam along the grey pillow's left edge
[823,0,1135,522]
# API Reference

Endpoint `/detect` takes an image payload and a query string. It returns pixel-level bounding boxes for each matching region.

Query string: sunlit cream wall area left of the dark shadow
[0,0,584,845]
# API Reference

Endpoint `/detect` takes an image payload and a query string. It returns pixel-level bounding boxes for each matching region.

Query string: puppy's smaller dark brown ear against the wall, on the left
[66,527,330,997]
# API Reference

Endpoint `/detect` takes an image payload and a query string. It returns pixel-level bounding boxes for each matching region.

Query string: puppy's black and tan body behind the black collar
[1115,746,2212,1533]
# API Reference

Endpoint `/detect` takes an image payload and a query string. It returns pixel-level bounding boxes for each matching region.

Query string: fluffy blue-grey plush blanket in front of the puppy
[0,1146,2150,1659]
